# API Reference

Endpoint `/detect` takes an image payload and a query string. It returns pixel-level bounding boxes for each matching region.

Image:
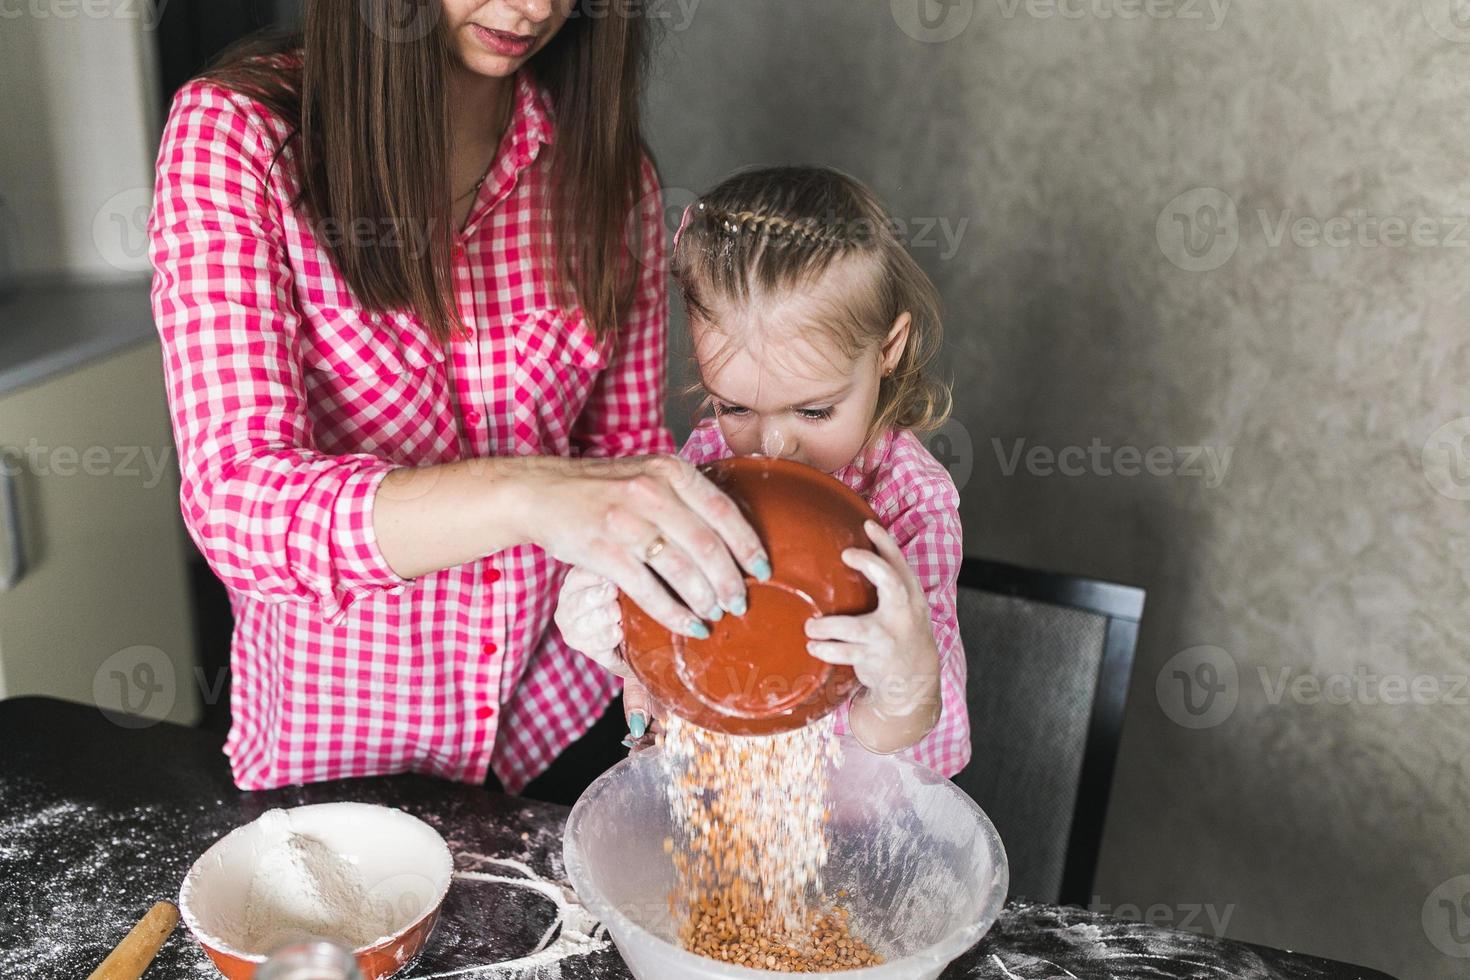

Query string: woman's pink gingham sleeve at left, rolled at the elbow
[148,82,406,621]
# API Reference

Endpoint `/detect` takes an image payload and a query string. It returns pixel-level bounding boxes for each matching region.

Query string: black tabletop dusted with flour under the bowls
[0,698,1386,980]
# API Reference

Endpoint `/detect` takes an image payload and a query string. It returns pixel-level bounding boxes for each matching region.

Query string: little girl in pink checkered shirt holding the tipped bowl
[556,167,970,776]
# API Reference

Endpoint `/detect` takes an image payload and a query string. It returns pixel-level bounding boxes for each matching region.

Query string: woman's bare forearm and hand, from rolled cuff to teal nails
[372,455,770,639]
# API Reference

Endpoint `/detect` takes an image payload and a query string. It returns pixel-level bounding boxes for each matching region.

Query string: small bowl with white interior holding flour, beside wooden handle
[179,804,454,980]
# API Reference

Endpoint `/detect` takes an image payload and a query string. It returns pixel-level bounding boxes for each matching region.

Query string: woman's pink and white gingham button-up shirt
[148,67,673,792]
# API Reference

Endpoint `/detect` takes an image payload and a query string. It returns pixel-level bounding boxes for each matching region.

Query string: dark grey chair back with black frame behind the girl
[954,558,1144,905]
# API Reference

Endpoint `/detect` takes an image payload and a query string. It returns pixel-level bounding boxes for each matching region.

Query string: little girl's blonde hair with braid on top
[673,166,951,439]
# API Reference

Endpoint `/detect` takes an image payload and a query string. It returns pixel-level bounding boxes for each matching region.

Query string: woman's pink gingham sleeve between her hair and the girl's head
[572,157,673,458]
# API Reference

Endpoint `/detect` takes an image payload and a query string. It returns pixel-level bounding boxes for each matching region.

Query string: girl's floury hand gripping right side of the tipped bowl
[807,520,939,734]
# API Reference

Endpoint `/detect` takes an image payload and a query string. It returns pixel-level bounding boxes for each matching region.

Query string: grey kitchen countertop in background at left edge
[0,279,157,395]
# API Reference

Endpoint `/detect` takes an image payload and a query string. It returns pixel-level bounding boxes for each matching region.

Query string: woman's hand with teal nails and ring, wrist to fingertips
[516,455,770,639]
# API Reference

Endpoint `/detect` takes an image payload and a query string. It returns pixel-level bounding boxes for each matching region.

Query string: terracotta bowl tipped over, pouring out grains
[619,457,878,735]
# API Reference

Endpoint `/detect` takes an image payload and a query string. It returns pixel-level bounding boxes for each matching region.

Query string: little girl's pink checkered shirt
[679,419,970,776]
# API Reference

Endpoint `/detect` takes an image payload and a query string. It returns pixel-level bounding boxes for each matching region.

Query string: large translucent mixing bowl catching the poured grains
[563,736,1008,980]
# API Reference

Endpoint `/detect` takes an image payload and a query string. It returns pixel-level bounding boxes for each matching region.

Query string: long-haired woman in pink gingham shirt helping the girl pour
[148,0,770,799]
